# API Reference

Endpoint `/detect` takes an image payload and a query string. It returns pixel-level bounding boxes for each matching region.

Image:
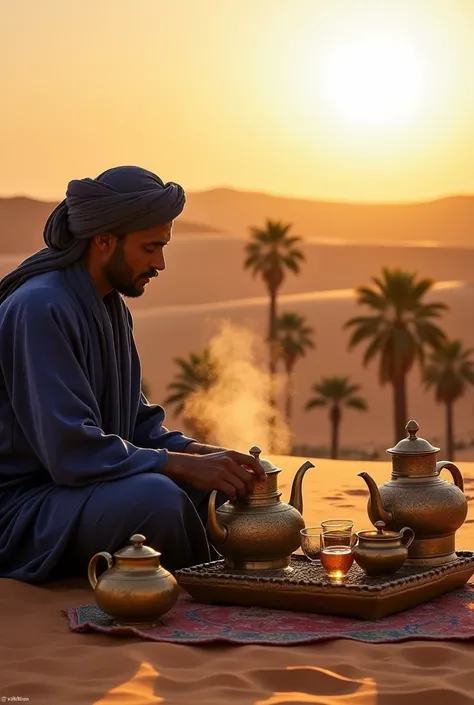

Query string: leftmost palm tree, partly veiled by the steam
[164,348,217,443]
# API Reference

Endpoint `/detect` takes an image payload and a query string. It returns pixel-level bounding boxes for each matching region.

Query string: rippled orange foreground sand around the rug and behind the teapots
[0,457,474,705]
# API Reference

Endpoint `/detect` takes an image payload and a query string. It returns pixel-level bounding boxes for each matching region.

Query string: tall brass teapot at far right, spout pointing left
[359,421,468,566]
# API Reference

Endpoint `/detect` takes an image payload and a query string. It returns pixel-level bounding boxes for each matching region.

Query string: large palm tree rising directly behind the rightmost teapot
[345,267,448,442]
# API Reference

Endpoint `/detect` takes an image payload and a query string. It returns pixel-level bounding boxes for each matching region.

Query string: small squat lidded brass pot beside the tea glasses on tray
[354,521,415,577]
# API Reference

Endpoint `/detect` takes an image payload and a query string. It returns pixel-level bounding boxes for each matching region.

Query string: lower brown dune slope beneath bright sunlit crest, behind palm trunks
[131,278,474,457]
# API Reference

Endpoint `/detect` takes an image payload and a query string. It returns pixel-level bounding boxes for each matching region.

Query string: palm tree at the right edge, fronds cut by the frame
[423,340,474,460]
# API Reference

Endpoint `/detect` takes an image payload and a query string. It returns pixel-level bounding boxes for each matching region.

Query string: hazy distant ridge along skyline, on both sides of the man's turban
[0,188,474,253]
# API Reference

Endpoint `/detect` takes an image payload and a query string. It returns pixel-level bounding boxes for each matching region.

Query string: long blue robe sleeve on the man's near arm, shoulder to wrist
[0,289,168,487]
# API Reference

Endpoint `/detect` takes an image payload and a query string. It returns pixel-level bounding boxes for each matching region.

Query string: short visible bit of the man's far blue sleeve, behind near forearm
[133,394,196,453]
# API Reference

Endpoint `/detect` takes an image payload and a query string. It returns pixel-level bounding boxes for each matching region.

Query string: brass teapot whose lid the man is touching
[207,446,314,570]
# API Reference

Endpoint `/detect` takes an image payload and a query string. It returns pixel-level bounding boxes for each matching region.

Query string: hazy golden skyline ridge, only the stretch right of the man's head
[185,189,474,247]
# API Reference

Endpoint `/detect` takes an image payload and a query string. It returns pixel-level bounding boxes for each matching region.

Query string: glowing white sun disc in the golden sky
[321,36,424,127]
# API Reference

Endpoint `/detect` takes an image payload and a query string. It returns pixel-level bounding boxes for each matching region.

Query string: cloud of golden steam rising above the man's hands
[184,321,291,455]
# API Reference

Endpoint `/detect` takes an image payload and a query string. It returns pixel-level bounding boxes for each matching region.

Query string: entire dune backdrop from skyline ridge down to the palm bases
[0,189,474,459]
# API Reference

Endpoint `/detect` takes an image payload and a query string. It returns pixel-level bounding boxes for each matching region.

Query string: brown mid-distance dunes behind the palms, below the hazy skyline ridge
[0,234,474,459]
